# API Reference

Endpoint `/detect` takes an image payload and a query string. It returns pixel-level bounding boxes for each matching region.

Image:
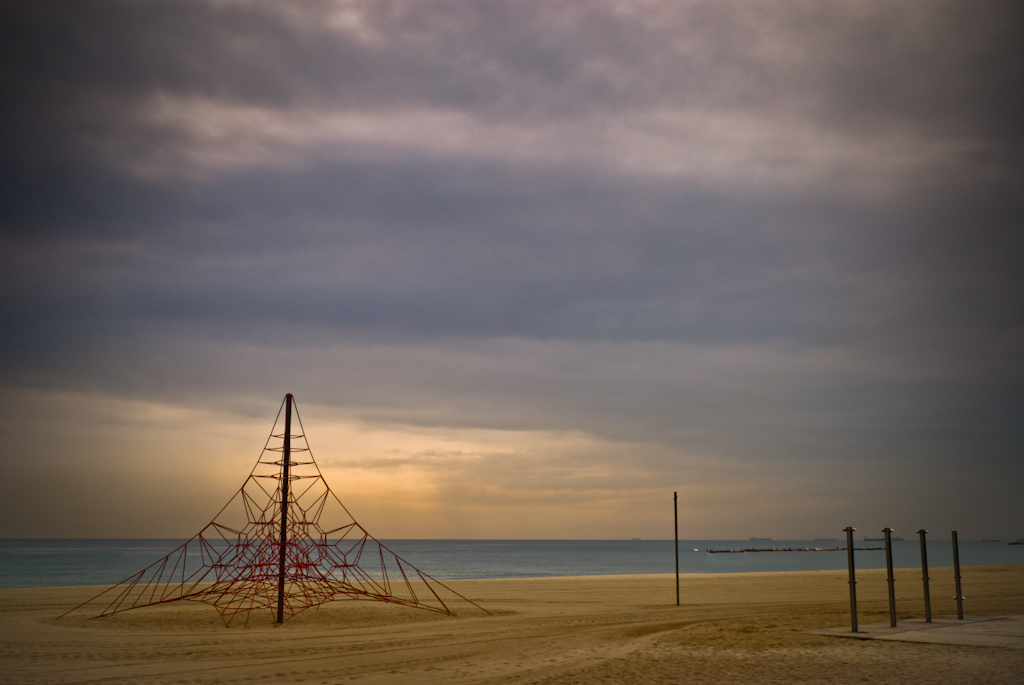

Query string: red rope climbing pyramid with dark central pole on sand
[62,394,487,626]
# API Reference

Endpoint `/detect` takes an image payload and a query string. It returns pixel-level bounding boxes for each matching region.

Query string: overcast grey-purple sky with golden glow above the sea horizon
[0,0,1024,539]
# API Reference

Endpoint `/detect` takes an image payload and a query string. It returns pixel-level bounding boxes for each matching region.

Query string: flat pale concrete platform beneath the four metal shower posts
[808,616,1024,649]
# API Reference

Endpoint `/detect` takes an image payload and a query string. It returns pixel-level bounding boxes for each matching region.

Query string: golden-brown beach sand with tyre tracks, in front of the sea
[0,565,1024,685]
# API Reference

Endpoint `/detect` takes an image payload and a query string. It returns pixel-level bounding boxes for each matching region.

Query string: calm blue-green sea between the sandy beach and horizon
[0,539,1024,588]
